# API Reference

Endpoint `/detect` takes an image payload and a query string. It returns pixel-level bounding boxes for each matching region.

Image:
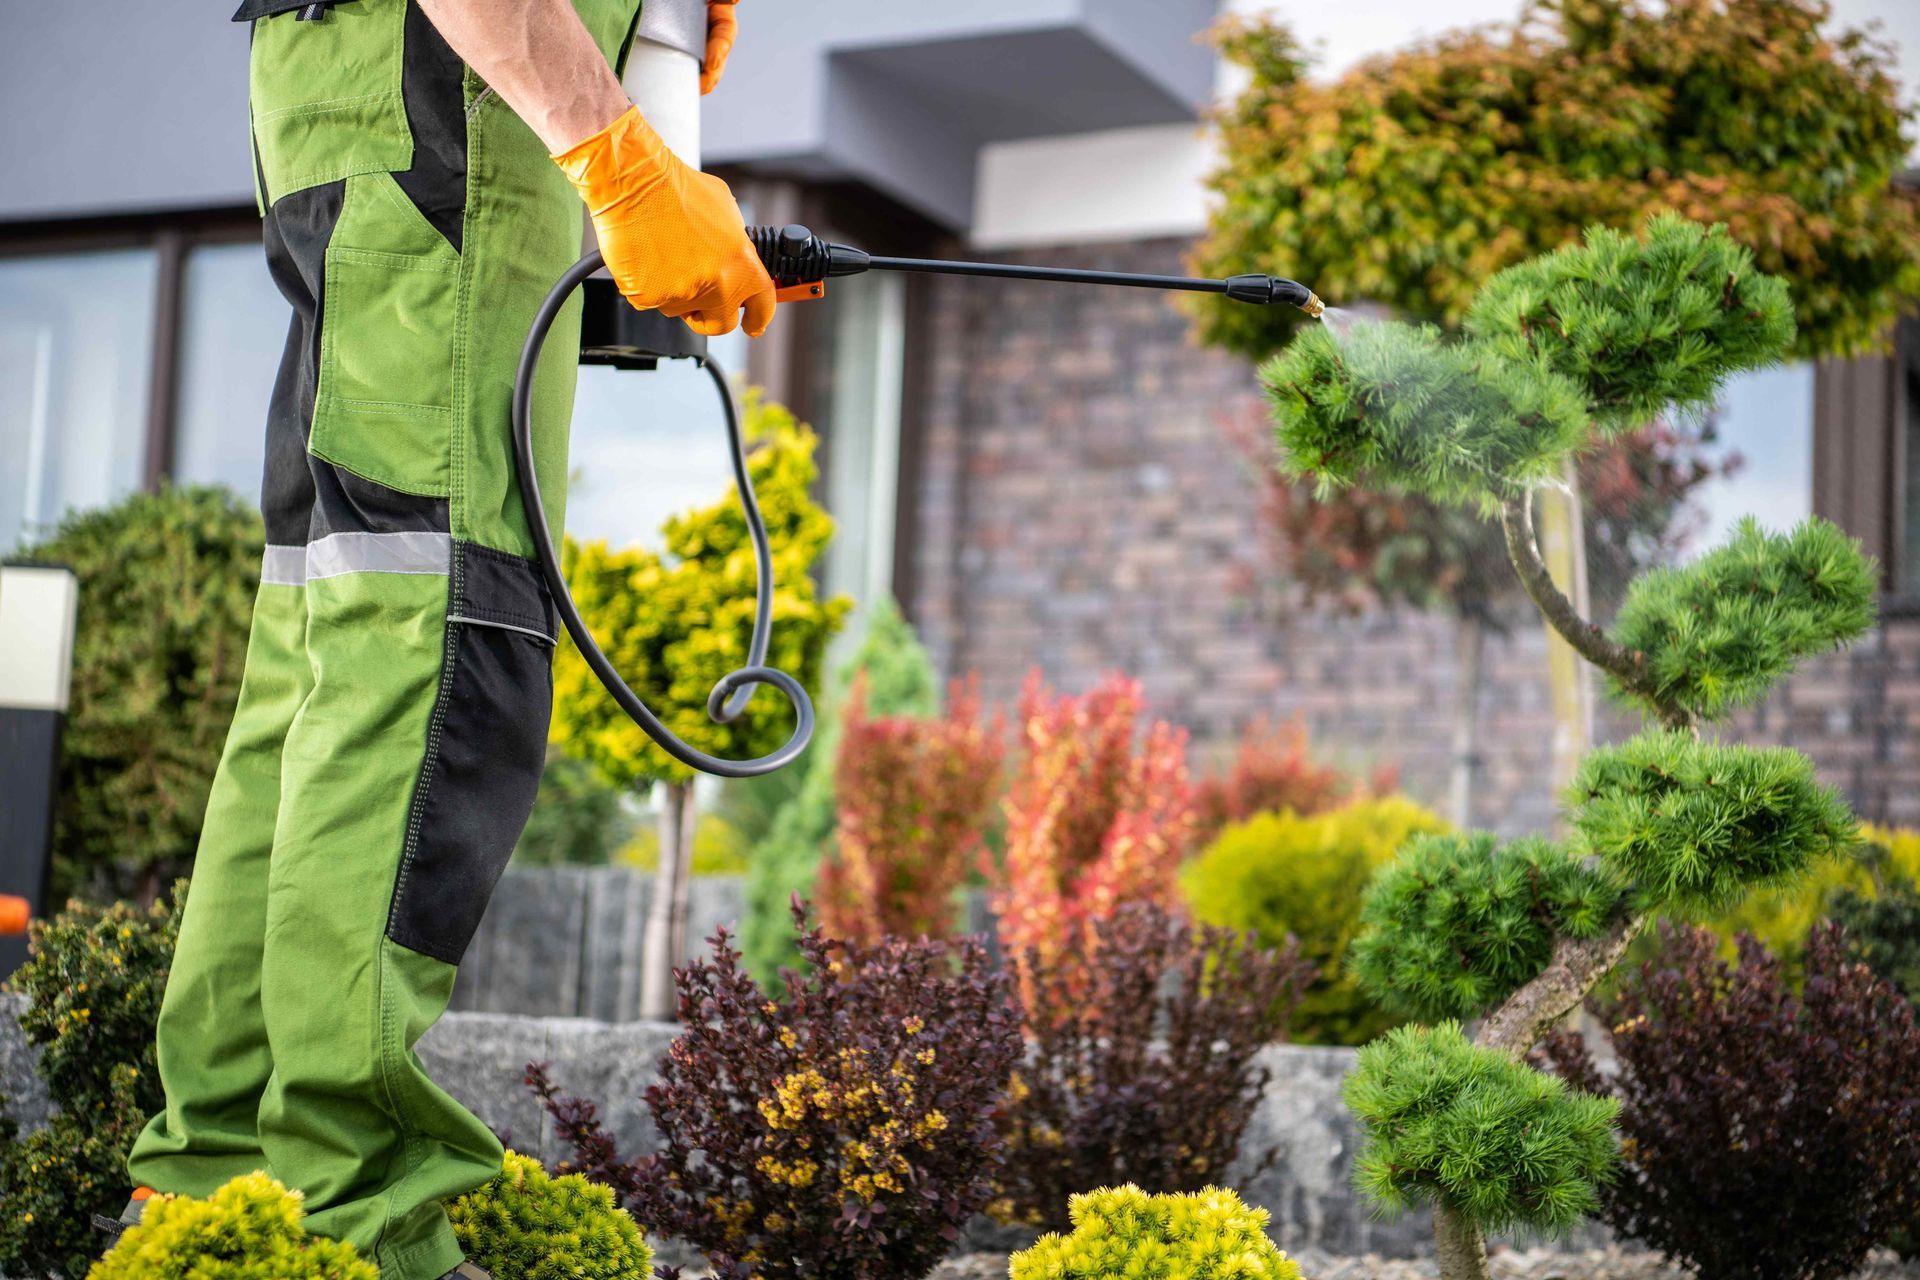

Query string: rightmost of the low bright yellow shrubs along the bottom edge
[1006,1186,1300,1280]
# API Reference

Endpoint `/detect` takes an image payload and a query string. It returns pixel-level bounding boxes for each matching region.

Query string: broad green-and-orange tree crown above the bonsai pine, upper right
[1194,0,1920,359]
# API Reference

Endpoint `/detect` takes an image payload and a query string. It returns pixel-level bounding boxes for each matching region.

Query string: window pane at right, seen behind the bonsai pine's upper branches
[1686,365,1812,555]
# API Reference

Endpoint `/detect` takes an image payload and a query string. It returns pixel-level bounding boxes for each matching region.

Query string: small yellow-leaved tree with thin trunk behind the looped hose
[553,395,849,1019]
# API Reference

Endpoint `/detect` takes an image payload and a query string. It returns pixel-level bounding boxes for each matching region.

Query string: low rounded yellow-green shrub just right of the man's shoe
[447,1151,653,1280]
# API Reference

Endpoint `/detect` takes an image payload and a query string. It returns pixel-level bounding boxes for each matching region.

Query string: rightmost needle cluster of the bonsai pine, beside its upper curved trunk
[1611,518,1878,720]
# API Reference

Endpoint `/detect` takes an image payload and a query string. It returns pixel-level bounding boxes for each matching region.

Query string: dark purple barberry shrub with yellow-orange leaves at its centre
[630,902,1021,1280]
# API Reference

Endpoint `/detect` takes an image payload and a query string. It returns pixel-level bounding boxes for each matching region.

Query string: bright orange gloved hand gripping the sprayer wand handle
[553,107,774,338]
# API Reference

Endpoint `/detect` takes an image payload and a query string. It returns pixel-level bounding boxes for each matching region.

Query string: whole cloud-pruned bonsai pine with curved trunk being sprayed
[1261,215,1876,1280]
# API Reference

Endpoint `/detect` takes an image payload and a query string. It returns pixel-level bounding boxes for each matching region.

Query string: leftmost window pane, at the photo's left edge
[0,249,159,549]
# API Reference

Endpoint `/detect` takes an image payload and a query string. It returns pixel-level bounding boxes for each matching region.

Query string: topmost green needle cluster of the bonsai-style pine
[1467,213,1793,432]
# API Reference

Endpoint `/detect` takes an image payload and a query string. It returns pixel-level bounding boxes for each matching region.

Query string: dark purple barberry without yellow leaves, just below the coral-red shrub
[991,902,1313,1230]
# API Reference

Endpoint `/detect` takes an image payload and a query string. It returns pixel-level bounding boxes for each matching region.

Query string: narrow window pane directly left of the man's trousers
[173,244,292,503]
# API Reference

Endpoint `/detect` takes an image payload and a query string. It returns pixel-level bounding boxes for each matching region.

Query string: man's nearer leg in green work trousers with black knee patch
[236,0,636,1280]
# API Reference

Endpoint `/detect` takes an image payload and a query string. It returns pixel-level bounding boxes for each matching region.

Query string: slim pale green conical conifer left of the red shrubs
[728,597,941,983]
